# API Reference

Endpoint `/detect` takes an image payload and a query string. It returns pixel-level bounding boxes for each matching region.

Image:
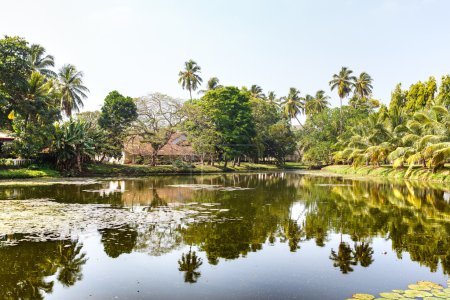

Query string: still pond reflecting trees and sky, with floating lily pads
[0,172,450,299]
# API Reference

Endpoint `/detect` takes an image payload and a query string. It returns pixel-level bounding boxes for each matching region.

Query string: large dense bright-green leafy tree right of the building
[199,87,254,167]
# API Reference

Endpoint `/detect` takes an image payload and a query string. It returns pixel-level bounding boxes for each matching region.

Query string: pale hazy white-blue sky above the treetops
[0,0,450,110]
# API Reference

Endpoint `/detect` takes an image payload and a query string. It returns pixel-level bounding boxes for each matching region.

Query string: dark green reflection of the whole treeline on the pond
[0,173,450,298]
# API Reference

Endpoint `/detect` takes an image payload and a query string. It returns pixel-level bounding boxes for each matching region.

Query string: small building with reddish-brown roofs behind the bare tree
[122,132,198,164]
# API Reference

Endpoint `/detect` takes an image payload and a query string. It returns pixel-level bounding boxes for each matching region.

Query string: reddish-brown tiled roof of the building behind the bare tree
[125,132,195,156]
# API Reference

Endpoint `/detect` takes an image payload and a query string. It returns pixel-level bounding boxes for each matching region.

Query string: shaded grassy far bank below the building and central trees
[83,163,305,176]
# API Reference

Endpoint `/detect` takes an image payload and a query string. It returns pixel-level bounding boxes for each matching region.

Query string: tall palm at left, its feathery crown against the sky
[58,64,89,117]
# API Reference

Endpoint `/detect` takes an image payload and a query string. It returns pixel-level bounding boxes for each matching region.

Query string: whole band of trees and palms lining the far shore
[0,36,450,175]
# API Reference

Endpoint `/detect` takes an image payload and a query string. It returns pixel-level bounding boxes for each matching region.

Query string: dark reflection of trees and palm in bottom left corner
[0,241,87,299]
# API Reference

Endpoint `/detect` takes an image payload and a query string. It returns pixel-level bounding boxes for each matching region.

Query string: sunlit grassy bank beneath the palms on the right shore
[322,165,450,183]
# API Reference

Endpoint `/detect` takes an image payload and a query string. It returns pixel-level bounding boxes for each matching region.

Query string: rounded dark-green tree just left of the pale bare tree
[98,91,137,158]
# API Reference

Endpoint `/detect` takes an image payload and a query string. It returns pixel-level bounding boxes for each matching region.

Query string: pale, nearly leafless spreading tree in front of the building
[129,93,184,166]
